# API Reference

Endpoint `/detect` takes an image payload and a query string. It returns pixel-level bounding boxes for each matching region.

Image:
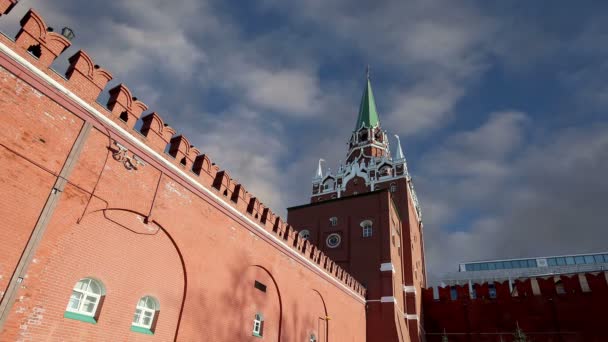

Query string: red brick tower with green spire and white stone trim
[288,73,426,341]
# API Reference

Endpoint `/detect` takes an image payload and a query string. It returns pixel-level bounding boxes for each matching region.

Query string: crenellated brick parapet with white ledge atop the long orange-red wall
[0,5,366,298]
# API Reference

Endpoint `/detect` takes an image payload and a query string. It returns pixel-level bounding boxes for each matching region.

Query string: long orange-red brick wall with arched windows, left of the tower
[0,6,366,342]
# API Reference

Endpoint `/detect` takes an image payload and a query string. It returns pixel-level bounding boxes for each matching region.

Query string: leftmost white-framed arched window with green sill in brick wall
[63,278,105,323]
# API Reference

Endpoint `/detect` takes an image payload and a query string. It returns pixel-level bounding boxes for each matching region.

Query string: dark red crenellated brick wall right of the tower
[423,272,608,342]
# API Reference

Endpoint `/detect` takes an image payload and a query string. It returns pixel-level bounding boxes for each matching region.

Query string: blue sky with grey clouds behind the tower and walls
[0,0,608,282]
